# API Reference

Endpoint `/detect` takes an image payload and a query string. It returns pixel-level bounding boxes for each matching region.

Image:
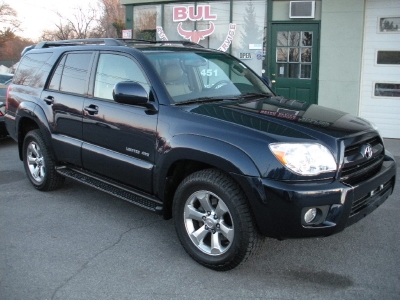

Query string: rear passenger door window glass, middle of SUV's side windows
[49,52,92,95]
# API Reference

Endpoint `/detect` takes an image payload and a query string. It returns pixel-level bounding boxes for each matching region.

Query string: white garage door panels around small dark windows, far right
[360,0,400,138]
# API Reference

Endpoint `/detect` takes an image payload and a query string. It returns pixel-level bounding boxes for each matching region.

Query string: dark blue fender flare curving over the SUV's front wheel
[154,134,260,195]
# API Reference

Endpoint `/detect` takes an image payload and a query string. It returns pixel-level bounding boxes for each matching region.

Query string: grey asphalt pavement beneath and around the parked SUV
[0,139,400,300]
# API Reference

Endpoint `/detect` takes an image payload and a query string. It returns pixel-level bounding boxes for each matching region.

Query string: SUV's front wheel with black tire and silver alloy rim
[173,169,264,271]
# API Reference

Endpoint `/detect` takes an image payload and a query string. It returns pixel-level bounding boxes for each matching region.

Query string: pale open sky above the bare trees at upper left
[9,0,98,41]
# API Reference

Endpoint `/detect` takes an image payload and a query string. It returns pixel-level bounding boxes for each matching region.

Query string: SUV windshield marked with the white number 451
[147,52,273,103]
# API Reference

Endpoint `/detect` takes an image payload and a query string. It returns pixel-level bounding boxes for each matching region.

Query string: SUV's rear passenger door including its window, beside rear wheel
[41,51,95,166]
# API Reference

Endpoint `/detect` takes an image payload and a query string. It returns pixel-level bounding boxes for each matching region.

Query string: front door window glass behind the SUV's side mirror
[94,53,150,100]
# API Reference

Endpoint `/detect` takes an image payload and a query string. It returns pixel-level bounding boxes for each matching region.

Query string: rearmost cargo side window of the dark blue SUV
[13,52,52,88]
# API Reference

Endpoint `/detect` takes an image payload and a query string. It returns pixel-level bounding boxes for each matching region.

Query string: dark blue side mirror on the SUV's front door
[113,81,149,106]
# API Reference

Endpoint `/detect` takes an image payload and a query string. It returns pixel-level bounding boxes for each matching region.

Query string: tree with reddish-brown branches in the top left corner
[0,1,21,46]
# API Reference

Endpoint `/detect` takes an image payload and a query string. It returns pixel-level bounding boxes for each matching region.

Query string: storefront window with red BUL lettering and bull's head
[133,0,267,75]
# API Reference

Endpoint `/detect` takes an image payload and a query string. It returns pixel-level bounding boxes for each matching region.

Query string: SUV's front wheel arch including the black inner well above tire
[154,135,260,219]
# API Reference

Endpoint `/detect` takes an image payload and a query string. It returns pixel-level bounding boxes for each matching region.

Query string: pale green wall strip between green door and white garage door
[318,0,365,115]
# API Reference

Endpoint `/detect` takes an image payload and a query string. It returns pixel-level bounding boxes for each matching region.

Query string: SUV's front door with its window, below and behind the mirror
[82,52,157,192]
